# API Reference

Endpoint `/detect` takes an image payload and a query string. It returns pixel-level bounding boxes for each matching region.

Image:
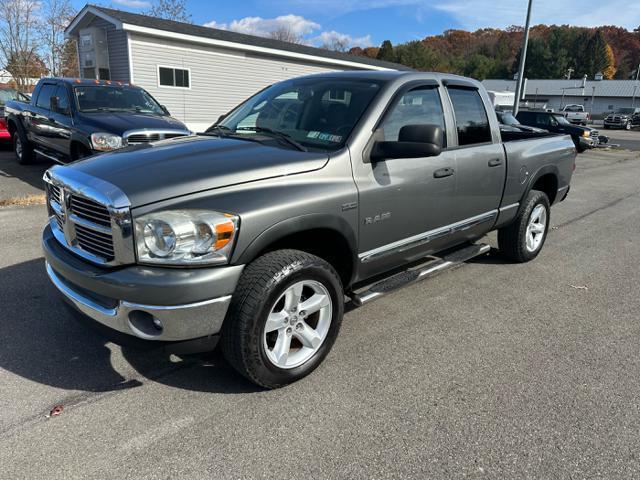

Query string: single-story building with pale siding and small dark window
[66,5,406,131]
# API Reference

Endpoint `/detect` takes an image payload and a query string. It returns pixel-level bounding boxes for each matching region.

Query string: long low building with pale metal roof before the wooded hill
[482,79,640,116]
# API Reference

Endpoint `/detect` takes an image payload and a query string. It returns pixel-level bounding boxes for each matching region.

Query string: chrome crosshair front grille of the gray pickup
[44,166,135,265]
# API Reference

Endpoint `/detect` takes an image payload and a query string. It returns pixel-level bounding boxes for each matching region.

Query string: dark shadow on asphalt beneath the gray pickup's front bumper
[0,259,259,396]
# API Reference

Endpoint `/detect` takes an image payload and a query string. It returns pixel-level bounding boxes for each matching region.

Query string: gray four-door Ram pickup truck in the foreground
[43,72,576,388]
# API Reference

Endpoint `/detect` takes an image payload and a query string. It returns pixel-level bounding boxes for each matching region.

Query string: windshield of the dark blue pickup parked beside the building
[74,85,166,115]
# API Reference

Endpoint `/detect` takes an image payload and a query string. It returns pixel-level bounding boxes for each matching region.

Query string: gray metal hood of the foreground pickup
[63,136,329,207]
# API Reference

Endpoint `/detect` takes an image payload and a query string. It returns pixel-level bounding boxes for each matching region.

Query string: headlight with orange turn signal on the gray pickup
[135,210,238,265]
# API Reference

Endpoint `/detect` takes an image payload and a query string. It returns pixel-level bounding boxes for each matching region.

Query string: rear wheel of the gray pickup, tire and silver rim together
[498,190,551,263]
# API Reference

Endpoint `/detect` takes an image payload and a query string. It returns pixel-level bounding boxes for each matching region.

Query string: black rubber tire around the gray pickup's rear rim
[498,190,551,263]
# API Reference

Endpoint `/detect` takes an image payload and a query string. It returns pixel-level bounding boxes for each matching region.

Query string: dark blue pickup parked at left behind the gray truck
[5,78,191,164]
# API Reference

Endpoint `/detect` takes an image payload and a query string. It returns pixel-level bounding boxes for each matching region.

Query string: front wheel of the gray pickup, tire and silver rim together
[222,250,344,388]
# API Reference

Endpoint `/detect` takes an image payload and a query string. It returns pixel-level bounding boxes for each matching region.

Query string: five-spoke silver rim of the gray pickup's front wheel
[262,280,333,369]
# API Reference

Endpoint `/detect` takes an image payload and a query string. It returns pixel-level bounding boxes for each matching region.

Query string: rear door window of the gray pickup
[447,87,492,147]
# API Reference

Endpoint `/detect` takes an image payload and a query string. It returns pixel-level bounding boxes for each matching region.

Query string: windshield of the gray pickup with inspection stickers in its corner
[215,77,382,151]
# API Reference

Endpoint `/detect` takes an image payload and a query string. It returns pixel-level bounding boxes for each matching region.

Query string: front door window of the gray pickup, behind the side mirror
[382,87,445,142]
